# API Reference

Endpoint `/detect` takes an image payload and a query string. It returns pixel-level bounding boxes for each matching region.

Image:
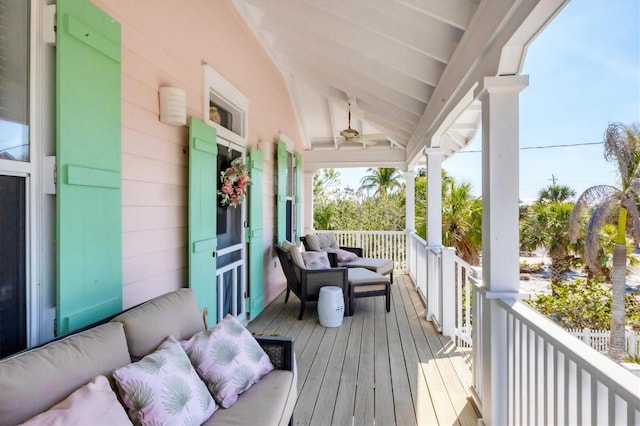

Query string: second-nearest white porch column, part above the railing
[425,149,444,246]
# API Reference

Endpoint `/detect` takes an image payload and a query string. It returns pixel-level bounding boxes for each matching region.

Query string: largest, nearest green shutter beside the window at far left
[56,0,122,334]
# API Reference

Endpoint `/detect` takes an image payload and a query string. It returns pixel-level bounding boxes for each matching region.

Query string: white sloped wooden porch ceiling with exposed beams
[234,0,567,171]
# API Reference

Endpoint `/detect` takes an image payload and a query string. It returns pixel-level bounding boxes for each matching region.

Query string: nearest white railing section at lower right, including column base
[473,283,640,425]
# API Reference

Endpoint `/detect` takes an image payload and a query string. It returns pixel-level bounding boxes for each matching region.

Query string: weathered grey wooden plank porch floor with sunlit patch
[248,275,478,426]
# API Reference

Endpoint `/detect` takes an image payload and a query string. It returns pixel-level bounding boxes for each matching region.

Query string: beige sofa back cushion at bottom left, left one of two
[0,323,131,424]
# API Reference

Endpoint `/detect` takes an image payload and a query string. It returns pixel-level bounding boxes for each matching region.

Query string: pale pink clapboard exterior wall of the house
[94,0,302,308]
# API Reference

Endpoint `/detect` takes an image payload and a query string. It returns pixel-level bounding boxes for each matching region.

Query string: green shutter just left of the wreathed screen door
[188,117,218,325]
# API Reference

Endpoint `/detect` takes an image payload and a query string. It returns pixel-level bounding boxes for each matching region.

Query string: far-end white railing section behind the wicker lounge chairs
[317,231,407,271]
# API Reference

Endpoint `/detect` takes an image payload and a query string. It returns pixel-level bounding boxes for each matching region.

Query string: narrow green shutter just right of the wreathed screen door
[247,148,264,320]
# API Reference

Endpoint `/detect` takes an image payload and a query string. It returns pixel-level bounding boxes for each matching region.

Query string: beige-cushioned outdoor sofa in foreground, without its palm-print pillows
[0,289,297,425]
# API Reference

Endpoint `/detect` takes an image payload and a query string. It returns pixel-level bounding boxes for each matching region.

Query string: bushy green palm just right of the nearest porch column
[520,185,576,283]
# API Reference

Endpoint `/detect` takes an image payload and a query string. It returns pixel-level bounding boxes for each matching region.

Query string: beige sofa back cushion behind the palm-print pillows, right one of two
[111,288,204,361]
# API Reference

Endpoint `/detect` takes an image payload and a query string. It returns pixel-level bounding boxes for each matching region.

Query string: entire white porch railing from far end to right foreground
[316,231,640,425]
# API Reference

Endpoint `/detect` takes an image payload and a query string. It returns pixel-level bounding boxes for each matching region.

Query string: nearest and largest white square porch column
[473,75,529,425]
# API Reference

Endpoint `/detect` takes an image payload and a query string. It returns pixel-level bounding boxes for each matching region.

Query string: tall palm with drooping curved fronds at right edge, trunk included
[569,123,640,362]
